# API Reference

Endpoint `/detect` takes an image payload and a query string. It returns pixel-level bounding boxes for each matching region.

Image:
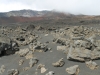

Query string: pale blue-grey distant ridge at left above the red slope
[0,10,61,17]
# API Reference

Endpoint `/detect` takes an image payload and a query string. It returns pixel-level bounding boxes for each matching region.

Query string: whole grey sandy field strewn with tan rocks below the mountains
[0,23,100,75]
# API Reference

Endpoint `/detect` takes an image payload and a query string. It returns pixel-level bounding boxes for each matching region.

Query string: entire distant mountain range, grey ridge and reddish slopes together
[0,10,100,25]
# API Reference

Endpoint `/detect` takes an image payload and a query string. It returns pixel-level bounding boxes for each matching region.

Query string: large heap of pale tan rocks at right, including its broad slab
[53,26,100,61]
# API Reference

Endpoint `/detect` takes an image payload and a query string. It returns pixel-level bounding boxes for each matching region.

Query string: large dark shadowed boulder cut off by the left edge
[0,37,19,56]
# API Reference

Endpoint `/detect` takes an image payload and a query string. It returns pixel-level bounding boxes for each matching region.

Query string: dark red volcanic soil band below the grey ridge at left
[0,17,43,24]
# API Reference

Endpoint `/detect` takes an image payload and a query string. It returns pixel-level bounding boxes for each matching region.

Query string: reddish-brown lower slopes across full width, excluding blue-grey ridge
[0,13,100,25]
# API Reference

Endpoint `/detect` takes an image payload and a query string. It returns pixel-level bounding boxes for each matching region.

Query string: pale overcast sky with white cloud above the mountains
[0,0,100,15]
